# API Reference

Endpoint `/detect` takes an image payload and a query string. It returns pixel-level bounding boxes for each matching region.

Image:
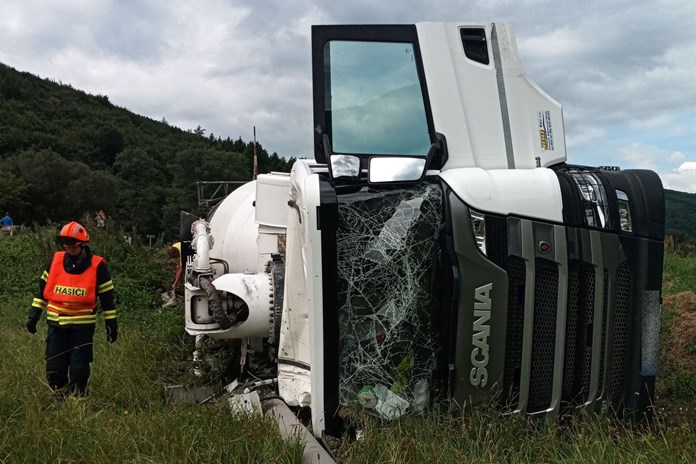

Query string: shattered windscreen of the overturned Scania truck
[337,183,442,419]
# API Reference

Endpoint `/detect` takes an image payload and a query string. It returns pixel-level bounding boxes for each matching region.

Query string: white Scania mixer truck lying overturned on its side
[182,23,664,436]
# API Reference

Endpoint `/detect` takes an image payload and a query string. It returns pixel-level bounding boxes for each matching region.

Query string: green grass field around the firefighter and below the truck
[0,231,696,464]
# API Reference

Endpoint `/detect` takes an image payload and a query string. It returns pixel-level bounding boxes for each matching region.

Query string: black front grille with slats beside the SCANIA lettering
[486,215,631,414]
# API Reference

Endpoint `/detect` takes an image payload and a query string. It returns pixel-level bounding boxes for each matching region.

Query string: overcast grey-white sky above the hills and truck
[0,0,696,193]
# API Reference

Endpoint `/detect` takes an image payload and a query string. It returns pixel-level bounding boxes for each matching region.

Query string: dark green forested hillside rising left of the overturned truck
[0,63,295,239]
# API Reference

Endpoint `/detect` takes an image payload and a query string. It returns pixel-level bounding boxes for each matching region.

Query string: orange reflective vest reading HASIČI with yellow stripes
[44,251,105,325]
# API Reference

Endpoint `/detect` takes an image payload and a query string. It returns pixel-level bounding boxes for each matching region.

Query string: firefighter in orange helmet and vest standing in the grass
[27,221,118,399]
